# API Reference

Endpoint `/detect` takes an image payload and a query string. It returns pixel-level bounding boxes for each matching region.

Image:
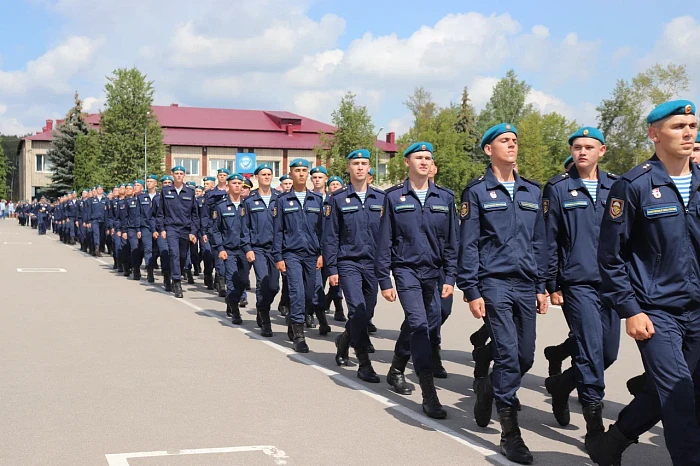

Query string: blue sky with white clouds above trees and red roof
[0,0,700,137]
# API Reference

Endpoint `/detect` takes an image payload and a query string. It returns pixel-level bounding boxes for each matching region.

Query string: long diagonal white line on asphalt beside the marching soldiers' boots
[150,286,515,466]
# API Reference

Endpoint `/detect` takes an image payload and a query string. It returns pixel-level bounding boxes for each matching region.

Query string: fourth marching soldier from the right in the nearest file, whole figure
[375,142,457,419]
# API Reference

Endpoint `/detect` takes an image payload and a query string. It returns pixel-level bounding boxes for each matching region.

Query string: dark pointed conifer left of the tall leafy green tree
[46,92,87,197]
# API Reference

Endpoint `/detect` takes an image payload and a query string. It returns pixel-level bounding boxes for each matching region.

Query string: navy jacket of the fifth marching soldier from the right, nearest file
[323,185,385,275]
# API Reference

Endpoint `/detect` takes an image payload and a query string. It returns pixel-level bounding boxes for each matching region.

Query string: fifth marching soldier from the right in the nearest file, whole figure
[323,149,384,383]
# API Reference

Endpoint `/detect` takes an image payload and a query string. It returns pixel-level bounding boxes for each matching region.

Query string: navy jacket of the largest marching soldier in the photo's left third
[156,186,199,235]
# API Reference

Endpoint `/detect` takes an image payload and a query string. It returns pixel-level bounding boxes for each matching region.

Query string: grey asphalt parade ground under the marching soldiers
[0,219,671,466]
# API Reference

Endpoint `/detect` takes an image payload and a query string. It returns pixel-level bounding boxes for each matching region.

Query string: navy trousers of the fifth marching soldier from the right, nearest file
[338,259,379,349]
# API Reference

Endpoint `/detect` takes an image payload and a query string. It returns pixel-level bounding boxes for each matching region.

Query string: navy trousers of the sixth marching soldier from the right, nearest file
[283,253,318,324]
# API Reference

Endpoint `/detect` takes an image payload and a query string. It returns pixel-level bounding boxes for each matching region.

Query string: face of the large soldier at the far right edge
[649,115,698,158]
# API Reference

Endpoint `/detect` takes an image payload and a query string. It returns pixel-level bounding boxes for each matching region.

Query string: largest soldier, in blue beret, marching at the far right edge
[588,100,700,465]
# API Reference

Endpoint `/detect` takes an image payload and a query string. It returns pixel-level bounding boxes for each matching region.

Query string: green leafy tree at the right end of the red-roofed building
[314,92,376,180]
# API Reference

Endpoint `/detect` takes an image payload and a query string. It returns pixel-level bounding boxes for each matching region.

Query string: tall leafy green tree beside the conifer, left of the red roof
[100,68,165,184]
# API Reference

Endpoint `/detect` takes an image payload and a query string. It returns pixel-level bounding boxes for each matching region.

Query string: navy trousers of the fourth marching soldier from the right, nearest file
[394,267,439,373]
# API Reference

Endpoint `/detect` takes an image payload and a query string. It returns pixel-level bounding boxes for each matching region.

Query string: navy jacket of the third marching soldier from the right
[457,166,547,300]
